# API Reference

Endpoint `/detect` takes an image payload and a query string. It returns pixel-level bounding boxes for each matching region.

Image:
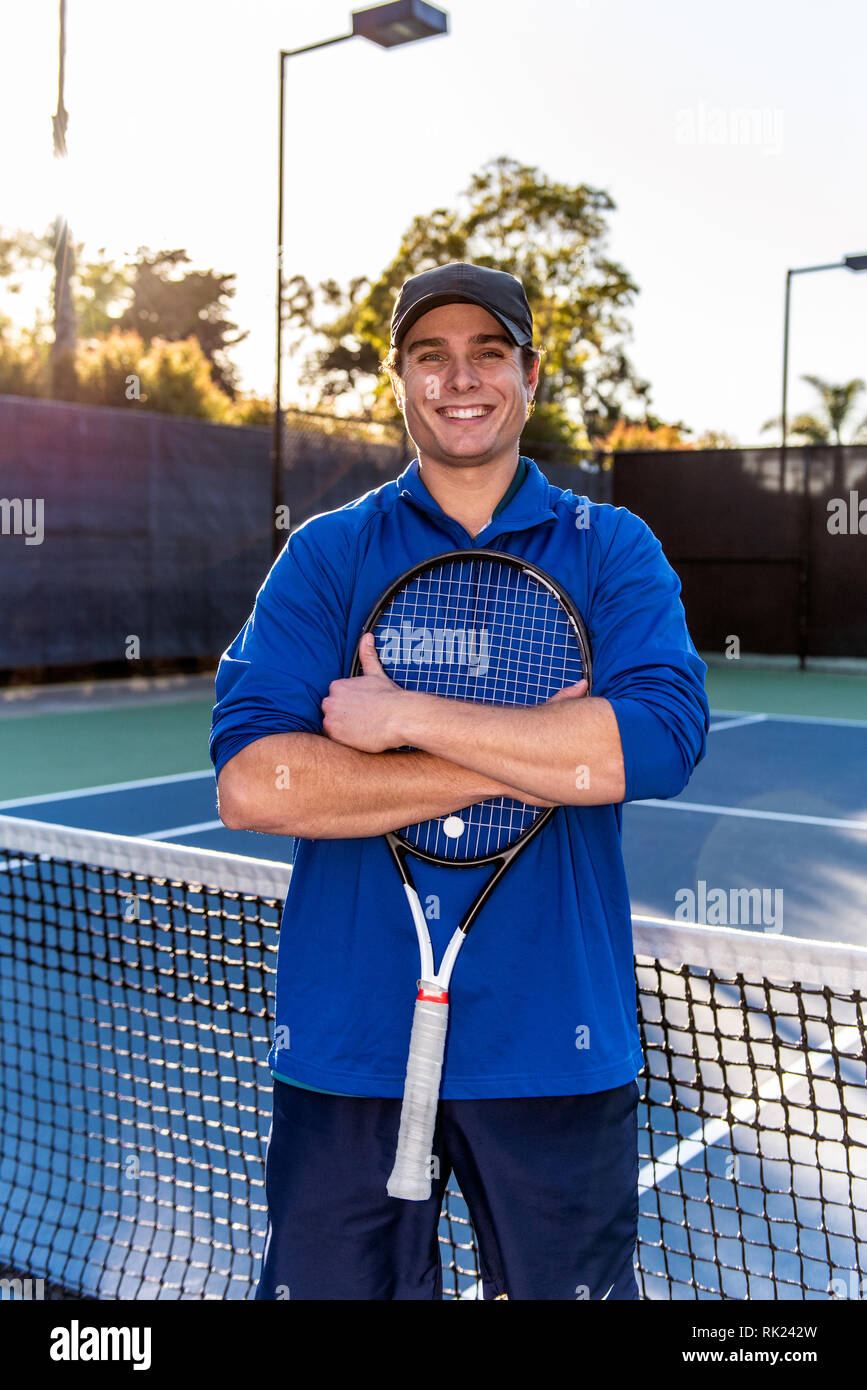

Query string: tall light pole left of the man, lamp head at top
[271,0,449,557]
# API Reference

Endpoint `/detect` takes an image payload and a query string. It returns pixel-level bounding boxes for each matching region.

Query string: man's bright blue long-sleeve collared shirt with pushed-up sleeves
[211,460,707,1099]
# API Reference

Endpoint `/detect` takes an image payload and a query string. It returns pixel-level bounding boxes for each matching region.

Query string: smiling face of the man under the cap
[395,303,538,466]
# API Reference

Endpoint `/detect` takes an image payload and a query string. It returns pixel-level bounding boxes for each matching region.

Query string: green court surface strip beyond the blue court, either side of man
[0,659,867,802]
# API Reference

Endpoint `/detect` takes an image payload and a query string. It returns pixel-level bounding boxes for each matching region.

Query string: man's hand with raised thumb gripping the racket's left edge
[322,632,414,753]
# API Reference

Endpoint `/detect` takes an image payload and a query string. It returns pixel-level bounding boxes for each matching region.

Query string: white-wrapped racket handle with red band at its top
[386,980,449,1202]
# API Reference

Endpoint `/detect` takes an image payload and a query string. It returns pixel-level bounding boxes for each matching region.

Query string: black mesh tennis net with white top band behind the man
[0,816,867,1300]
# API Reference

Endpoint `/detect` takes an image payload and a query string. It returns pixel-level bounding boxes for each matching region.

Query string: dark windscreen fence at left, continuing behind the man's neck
[0,396,611,681]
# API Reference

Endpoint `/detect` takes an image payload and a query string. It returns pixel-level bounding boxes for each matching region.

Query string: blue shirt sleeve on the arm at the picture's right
[588,509,709,801]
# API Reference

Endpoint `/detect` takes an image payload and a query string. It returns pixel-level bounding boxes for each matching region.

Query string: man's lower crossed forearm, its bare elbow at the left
[213,734,547,840]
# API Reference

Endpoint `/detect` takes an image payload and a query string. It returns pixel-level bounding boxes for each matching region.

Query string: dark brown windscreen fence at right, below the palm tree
[613,446,867,657]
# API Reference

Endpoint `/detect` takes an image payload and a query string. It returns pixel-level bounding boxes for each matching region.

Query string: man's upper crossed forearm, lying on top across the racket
[395,692,625,806]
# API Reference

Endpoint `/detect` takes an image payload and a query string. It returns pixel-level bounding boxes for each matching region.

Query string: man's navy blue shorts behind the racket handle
[256,1081,639,1301]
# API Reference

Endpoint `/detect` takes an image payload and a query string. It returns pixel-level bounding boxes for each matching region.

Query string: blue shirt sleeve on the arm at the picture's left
[210,518,350,777]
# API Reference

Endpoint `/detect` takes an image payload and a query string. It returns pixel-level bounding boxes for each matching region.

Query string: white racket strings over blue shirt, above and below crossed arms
[374,560,584,860]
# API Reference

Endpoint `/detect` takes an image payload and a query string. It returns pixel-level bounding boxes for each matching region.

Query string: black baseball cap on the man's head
[392,261,532,348]
